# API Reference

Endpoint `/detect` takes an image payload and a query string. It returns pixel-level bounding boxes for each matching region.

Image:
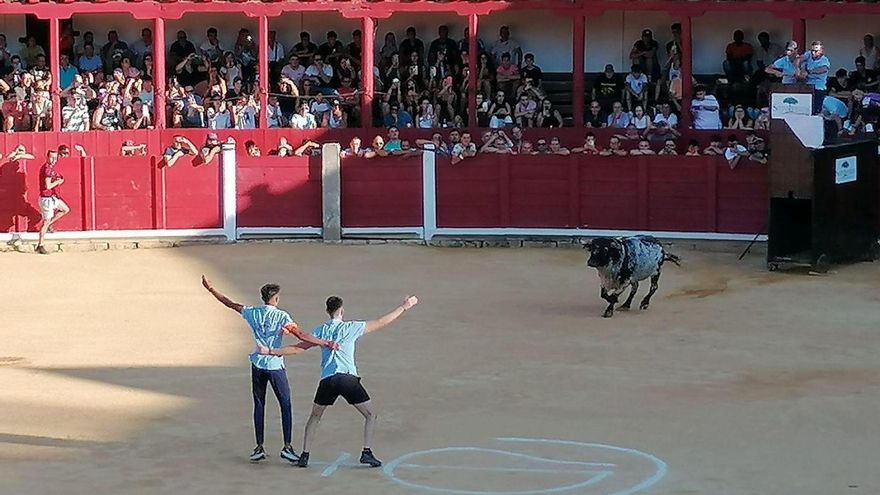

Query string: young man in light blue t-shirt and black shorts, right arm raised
[259,296,419,467]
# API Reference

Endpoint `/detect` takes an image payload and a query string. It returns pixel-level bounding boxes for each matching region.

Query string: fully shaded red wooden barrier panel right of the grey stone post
[341,154,423,227]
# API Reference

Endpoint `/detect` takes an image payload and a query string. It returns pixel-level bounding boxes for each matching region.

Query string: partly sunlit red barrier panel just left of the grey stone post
[236,156,322,227]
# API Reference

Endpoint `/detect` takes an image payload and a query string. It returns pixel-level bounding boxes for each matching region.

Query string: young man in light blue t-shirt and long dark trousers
[202,275,339,462]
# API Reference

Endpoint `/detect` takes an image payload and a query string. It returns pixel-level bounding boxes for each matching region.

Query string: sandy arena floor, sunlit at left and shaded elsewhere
[0,244,880,495]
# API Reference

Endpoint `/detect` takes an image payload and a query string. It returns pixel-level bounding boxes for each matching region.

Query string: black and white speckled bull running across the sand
[584,235,681,318]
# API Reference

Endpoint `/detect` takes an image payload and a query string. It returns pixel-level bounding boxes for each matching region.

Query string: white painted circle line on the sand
[383,437,668,495]
